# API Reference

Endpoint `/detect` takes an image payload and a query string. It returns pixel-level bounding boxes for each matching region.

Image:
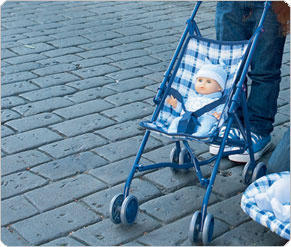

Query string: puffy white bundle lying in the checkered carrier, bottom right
[255,177,290,222]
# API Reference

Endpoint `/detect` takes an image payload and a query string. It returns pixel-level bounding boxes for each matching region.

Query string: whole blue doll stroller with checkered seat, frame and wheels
[110,2,270,245]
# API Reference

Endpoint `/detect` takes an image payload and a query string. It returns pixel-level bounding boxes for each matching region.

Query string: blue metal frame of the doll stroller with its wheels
[110,1,271,245]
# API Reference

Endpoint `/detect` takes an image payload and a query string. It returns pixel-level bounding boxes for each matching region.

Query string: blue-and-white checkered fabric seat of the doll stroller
[142,36,249,139]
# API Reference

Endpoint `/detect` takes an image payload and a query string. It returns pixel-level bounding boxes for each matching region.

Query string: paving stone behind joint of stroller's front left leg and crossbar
[89,157,150,186]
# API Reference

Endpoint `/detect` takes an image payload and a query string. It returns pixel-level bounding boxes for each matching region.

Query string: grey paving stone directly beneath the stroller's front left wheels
[72,213,160,246]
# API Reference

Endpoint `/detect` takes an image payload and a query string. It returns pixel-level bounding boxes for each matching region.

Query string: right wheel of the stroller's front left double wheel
[120,195,138,225]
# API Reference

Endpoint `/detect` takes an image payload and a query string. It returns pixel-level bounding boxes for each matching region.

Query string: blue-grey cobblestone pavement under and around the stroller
[1,1,290,246]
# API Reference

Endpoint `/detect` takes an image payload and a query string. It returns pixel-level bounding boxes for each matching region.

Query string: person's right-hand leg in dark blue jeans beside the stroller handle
[247,2,285,137]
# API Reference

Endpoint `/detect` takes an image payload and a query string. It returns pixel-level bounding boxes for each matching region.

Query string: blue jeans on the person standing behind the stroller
[215,1,285,136]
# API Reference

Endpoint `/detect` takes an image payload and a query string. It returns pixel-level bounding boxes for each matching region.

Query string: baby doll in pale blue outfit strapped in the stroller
[166,61,227,136]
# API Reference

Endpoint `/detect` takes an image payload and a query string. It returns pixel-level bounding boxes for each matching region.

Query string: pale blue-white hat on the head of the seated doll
[196,64,227,91]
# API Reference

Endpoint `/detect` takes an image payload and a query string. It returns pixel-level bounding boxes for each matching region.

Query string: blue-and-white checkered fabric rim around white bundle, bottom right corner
[241,172,290,239]
